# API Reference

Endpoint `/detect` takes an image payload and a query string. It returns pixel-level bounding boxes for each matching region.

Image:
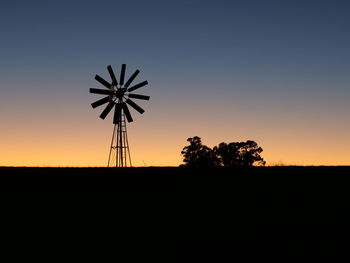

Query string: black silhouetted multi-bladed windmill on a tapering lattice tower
[90,64,149,167]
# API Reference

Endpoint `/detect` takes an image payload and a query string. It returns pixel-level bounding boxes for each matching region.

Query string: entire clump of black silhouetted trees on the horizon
[181,136,266,167]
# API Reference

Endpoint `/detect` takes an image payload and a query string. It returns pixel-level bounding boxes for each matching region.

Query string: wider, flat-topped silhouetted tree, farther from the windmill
[213,140,266,167]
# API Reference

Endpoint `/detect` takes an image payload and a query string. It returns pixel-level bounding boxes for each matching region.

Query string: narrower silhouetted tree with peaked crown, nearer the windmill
[181,136,220,168]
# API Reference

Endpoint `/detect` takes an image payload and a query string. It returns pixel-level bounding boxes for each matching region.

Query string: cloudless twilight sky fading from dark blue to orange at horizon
[0,0,350,167]
